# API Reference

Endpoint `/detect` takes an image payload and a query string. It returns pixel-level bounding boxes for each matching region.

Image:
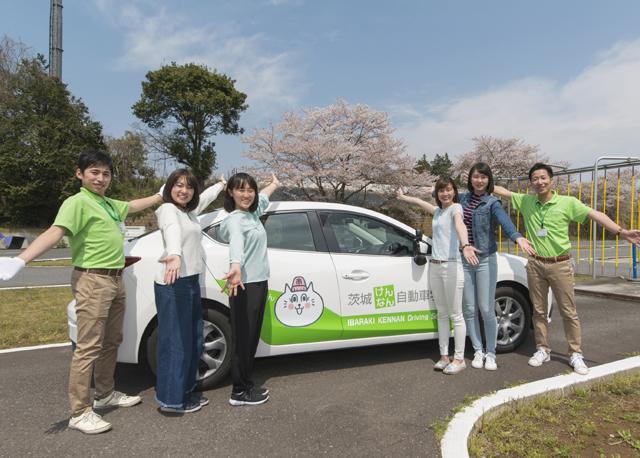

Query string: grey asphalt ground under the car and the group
[0,296,640,457]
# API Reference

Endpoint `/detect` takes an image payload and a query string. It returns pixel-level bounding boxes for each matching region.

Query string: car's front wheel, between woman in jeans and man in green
[495,286,531,353]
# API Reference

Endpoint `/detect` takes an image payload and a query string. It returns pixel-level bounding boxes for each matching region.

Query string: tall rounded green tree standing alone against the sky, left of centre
[132,62,248,183]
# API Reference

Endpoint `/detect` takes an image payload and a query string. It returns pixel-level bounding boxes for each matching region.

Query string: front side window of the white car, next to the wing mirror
[324,213,413,256]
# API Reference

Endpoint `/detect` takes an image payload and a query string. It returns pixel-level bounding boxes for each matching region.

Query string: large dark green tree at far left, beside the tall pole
[0,40,104,226]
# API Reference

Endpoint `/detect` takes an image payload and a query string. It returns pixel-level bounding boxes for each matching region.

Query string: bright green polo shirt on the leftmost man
[53,188,129,269]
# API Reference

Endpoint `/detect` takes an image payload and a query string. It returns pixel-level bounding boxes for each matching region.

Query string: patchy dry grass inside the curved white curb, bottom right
[469,372,640,457]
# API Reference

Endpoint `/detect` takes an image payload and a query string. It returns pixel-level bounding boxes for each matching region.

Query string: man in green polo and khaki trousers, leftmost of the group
[0,151,162,434]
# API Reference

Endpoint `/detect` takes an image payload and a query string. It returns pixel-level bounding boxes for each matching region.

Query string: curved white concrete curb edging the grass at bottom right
[440,356,640,458]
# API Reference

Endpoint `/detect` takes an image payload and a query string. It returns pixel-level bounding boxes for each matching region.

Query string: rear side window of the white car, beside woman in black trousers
[262,213,316,251]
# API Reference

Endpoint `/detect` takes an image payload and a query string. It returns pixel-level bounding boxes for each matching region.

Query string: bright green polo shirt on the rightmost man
[511,192,591,257]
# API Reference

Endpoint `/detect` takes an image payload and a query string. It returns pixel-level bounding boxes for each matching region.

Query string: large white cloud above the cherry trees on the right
[390,40,640,166]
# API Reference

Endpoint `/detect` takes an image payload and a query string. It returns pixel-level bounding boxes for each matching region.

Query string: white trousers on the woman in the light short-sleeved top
[429,261,467,359]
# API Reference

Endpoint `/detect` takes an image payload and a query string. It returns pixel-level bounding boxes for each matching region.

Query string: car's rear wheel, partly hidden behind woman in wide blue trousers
[146,305,231,390]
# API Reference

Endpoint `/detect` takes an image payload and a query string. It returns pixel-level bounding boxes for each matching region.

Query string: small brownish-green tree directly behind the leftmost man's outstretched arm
[105,131,160,200]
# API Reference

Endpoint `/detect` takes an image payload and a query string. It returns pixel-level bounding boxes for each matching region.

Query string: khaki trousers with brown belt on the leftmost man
[69,270,125,416]
